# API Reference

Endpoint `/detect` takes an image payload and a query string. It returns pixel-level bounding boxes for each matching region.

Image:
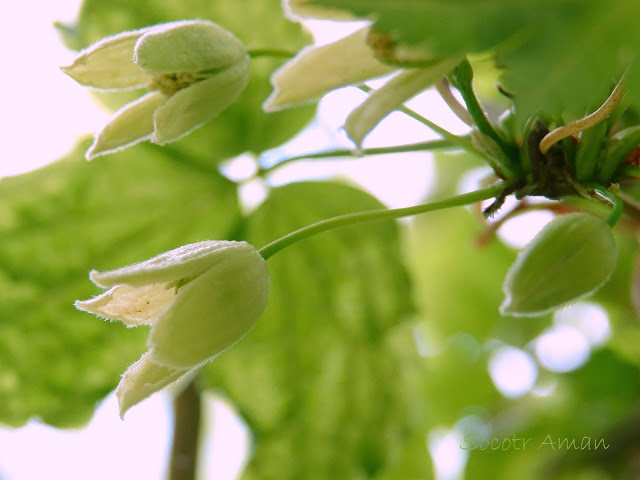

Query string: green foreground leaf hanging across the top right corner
[297,0,640,119]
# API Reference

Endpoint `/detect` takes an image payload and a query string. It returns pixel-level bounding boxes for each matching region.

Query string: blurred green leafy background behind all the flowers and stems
[0,0,640,480]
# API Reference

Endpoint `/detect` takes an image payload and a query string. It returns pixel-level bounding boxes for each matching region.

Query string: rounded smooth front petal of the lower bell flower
[148,242,269,368]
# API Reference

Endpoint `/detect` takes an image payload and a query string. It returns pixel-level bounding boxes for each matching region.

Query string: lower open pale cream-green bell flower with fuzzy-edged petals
[76,241,269,414]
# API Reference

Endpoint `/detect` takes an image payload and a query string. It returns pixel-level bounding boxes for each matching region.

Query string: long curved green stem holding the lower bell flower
[259,182,509,260]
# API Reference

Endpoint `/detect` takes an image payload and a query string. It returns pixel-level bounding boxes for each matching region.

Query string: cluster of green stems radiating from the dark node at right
[258,57,635,259]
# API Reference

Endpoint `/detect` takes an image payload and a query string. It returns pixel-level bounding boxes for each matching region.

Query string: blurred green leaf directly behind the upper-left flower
[64,0,314,162]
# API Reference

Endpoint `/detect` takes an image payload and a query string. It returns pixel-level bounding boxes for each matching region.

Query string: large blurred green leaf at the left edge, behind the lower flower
[0,142,239,427]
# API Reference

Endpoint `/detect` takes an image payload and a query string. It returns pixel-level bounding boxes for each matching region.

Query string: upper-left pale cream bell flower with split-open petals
[62,20,249,159]
